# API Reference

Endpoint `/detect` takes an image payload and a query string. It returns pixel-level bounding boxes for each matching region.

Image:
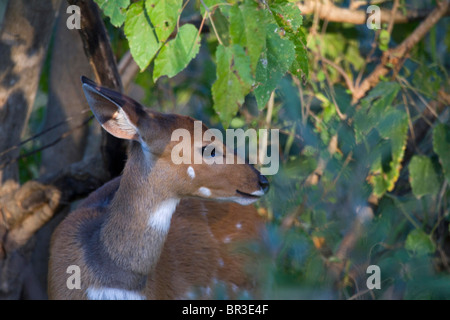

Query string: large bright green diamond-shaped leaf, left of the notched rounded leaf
[124,1,161,71]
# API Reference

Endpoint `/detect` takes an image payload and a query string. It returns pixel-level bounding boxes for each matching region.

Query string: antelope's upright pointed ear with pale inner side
[81,76,146,140]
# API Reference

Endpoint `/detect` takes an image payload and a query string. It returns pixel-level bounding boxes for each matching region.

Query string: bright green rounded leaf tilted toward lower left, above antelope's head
[153,24,200,81]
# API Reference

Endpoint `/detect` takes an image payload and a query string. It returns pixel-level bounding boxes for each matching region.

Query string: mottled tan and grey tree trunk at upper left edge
[0,0,60,184]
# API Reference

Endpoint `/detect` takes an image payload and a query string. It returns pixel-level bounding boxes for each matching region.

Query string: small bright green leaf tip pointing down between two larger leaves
[145,0,183,42]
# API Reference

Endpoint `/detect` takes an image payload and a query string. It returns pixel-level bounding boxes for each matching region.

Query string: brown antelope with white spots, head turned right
[49,80,263,299]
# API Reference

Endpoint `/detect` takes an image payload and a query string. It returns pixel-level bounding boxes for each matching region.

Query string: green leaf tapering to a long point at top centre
[230,1,267,74]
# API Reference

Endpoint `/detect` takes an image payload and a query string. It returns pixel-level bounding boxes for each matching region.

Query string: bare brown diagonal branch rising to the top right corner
[352,0,450,103]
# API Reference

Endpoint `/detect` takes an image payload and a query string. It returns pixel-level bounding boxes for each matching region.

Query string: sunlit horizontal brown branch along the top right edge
[297,0,450,24]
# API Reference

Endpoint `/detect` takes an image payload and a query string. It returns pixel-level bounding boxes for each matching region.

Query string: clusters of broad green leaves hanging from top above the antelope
[97,0,308,127]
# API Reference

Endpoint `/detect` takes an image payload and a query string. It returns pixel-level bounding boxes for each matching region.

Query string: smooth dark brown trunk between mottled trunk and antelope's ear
[40,1,93,175]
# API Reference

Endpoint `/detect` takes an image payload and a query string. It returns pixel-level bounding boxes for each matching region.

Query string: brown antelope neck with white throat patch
[101,143,179,275]
